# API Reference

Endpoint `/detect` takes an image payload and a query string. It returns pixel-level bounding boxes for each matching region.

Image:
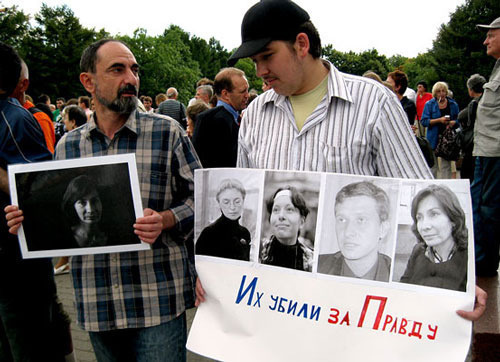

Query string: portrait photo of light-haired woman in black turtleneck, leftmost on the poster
[195,170,262,261]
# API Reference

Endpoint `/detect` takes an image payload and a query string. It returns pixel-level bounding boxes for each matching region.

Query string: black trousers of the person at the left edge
[0,256,67,362]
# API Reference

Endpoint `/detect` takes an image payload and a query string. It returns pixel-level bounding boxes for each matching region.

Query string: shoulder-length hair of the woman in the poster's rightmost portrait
[411,185,469,250]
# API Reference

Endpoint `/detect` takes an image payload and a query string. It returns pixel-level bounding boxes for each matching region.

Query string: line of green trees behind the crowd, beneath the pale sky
[0,0,500,107]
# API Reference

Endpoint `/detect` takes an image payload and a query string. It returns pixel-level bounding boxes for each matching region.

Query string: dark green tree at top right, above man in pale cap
[431,0,500,107]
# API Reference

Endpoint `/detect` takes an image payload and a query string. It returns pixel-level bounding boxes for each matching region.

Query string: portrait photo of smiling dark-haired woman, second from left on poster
[259,171,321,272]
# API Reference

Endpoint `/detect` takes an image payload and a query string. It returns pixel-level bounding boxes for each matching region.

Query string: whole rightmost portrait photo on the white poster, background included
[393,183,469,292]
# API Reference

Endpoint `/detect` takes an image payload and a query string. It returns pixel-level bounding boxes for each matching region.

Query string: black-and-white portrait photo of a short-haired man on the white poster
[317,176,399,282]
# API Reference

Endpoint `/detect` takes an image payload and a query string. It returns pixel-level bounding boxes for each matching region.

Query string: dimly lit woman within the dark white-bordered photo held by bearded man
[62,175,108,248]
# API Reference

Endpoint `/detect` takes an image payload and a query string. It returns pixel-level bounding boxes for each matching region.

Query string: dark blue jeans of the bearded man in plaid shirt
[89,313,187,362]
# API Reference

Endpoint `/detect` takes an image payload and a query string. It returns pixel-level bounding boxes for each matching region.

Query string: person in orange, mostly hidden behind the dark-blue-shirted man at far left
[10,61,56,154]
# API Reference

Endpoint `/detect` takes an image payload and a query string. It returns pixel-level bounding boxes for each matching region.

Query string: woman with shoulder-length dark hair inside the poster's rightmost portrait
[401,185,468,291]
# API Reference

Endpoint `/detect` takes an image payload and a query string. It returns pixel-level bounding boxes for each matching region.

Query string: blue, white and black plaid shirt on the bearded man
[56,112,200,331]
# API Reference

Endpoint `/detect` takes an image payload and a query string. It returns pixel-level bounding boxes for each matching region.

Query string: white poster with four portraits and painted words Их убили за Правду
[187,169,475,361]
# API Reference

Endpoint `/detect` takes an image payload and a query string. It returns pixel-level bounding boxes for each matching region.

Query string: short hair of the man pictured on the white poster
[335,181,390,221]
